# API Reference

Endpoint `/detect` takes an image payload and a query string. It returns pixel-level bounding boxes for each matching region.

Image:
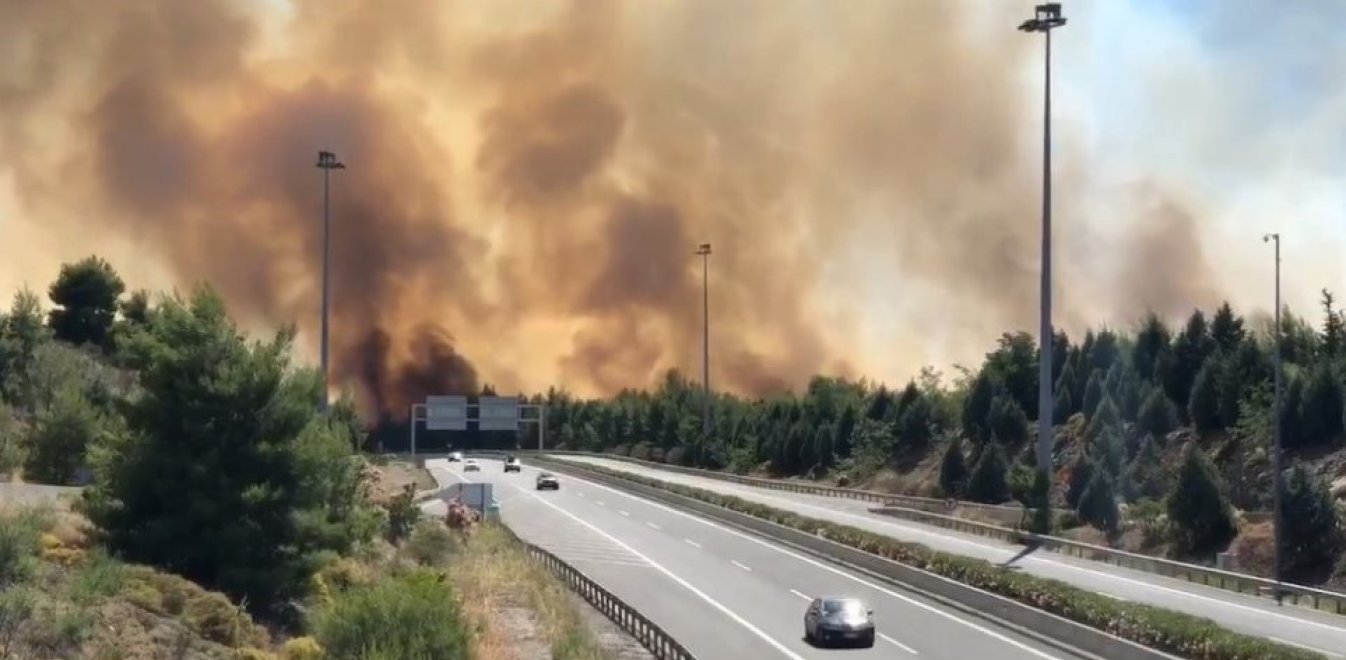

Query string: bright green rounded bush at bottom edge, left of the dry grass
[311,568,472,660]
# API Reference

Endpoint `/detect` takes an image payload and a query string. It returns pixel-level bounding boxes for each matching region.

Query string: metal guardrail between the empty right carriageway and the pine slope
[871,506,1346,614]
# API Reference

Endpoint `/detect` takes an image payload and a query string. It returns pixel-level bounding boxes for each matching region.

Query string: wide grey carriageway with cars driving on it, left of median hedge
[423,459,1079,660]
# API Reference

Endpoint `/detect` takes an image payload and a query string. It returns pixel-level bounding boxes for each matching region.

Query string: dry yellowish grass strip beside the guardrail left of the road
[428,524,606,660]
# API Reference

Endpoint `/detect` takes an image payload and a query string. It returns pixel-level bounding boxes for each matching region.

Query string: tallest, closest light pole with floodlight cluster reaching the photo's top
[1019,3,1066,477]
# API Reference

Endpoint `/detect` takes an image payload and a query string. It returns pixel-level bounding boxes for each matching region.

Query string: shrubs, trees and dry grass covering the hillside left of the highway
[0,257,616,660]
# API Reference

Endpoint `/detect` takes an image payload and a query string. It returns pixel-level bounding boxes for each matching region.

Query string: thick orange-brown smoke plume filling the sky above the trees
[0,0,1209,414]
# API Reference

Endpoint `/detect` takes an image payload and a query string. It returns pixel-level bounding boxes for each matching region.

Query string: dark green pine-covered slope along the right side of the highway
[524,299,1346,589]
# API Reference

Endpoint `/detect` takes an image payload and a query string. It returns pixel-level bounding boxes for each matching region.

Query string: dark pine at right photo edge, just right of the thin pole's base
[1281,463,1343,572]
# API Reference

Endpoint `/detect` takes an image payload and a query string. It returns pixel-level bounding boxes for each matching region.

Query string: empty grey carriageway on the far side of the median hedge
[552,455,1346,659]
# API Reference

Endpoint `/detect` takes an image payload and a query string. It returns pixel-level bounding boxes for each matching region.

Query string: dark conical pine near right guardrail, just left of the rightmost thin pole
[1167,443,1237,555]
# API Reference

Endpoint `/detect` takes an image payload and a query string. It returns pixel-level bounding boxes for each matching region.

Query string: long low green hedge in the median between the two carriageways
[559,465,1322,660]
